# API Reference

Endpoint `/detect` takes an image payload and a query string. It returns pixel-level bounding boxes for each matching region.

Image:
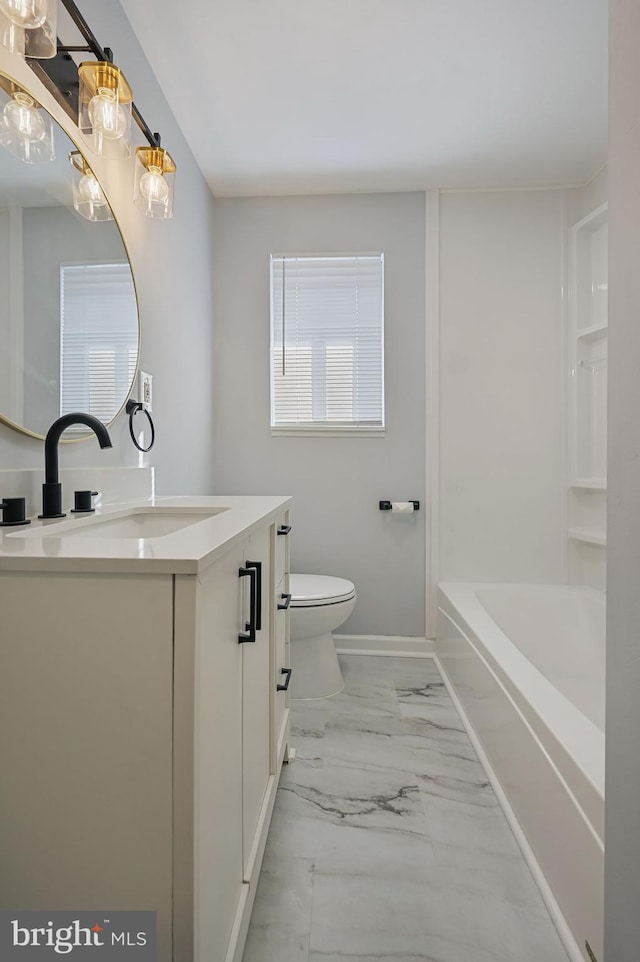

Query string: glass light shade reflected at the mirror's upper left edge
[0,78,56,164]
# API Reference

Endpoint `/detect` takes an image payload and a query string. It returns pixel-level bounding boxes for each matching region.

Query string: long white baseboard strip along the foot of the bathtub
[433,654,584,962]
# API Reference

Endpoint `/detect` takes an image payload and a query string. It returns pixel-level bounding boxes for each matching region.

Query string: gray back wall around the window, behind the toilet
[213,193,425,637]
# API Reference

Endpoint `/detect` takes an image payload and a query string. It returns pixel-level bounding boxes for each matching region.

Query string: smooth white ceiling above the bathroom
[122,0,607,196]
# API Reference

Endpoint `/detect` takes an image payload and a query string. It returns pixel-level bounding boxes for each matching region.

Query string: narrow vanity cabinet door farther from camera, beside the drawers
[241,526,273,881]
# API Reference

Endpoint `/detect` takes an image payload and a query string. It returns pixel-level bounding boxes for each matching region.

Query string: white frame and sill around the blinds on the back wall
[269,250,386,438]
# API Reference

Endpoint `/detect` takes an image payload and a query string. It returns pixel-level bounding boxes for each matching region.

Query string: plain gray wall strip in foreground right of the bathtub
[605,0,640,962]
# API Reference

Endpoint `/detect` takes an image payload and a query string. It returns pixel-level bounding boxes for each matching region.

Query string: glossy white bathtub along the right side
[436,583,605,960]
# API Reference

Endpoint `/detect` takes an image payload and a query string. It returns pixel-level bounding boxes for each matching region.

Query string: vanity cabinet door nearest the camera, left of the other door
[194,547,248,962]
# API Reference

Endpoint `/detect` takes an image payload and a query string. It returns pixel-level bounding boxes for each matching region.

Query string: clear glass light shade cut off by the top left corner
[0,0,58,60]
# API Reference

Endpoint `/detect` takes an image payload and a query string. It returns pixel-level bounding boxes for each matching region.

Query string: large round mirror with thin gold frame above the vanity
[0,74,139,437]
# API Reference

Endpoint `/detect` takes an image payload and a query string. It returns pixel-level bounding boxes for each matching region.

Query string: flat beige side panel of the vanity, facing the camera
[0,571,173,962]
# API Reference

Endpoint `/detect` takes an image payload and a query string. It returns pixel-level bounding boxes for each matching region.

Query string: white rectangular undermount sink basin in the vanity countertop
[11,507,229,540]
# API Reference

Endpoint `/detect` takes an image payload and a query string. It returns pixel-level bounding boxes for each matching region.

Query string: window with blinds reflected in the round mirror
[60,261,138,424]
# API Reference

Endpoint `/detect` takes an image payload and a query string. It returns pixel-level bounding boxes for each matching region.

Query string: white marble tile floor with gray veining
[244,655,567,962]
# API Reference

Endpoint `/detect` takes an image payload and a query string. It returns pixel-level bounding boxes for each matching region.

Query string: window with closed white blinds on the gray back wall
[271,254,384,433]
